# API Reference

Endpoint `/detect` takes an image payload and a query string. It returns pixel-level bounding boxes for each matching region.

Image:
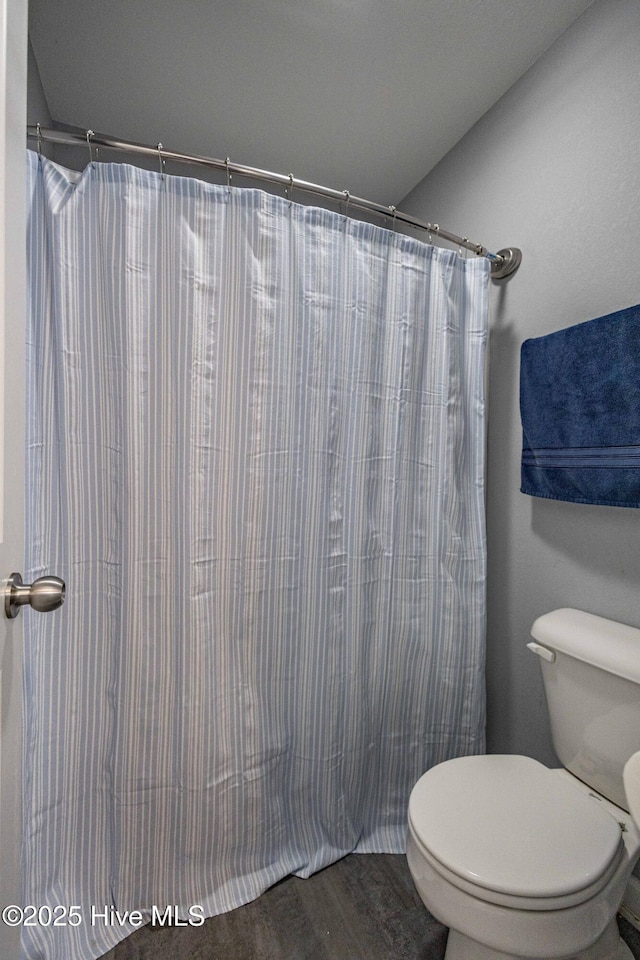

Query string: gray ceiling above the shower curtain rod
[29,0,593,204]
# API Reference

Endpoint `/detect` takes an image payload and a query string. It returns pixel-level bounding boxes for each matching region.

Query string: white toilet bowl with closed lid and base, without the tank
[407,755,640,960]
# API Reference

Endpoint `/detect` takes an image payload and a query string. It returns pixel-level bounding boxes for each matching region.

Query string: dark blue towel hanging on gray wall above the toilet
[520,305,640,507]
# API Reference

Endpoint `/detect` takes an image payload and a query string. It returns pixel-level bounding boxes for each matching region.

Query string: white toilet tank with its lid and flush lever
[528,608,640,810]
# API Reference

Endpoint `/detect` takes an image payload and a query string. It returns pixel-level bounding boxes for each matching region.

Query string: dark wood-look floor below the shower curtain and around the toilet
[104,854,640,960]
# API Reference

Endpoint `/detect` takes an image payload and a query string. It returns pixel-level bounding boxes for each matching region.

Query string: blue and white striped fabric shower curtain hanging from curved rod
[23,154,489,960]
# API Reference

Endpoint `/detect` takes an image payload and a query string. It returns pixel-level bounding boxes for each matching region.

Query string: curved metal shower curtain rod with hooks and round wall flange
[27,123,522,280]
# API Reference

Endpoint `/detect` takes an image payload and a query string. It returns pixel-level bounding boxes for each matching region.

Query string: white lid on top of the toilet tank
[531,607,640,684]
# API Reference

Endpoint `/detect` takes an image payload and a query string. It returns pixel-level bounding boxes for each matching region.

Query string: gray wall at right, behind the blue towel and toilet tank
[402,0,640,763]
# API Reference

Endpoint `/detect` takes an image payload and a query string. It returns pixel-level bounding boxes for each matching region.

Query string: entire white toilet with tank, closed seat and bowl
[407,609,640,960]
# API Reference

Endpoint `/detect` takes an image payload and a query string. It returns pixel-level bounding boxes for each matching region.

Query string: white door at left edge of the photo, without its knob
[0,0,28,948]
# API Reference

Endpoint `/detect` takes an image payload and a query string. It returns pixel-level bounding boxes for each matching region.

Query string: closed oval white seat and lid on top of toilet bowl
[409,755,624,910]
